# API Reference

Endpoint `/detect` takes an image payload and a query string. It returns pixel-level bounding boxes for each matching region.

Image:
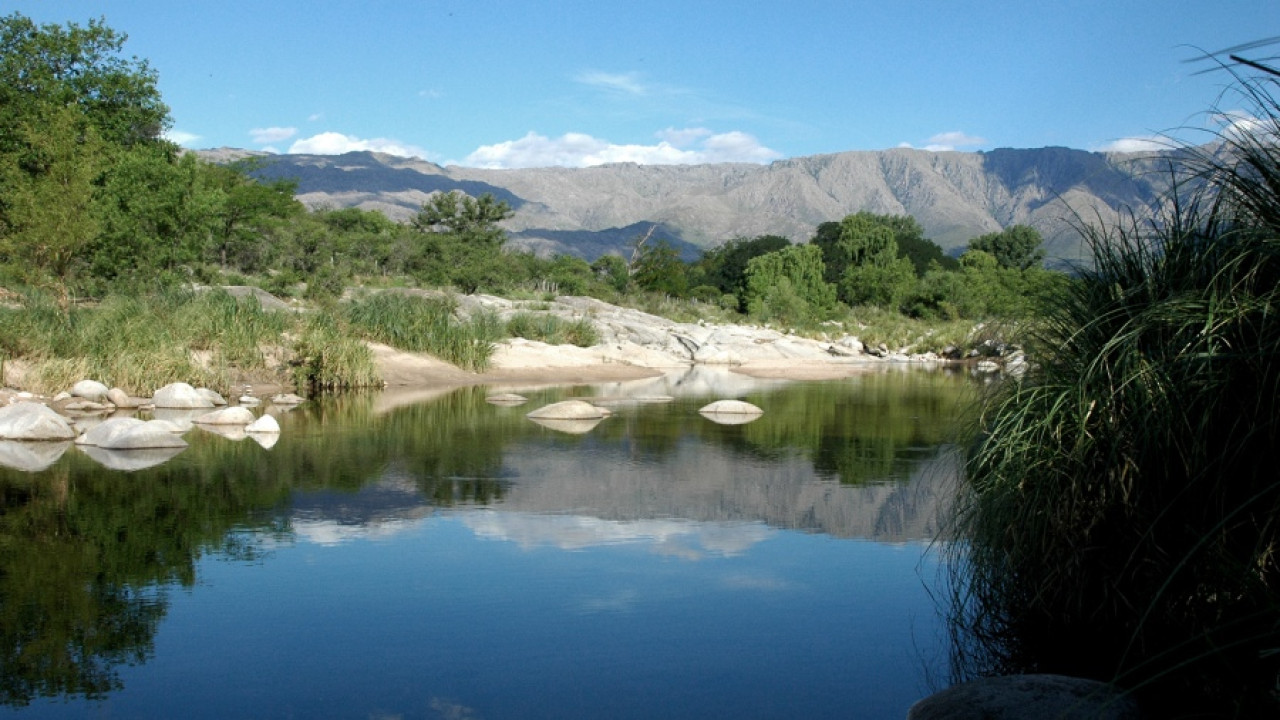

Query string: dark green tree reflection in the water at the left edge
[0,455,291,706]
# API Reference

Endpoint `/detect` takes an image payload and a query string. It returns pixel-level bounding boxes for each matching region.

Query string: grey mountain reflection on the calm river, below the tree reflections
[499,442,957,542]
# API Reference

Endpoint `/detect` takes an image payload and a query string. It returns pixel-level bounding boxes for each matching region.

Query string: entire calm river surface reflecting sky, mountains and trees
[0,372,969,719]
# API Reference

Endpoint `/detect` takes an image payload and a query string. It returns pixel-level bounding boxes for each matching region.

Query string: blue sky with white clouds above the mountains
[10,0,1280,167]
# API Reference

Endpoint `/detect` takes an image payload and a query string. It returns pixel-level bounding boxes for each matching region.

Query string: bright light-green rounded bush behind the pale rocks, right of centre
[746,245,836,324]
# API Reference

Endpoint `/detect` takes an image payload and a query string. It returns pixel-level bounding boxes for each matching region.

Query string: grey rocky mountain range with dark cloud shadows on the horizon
[201,147,1167,260]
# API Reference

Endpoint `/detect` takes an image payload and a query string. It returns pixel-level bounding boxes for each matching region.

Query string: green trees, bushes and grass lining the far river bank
[0,14,1068,391]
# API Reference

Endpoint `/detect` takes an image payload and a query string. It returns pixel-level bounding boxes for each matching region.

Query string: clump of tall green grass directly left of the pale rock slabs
[344,292,500,372]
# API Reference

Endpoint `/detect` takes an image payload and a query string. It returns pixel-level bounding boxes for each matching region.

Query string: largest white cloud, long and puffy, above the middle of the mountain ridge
[461,128,782,168]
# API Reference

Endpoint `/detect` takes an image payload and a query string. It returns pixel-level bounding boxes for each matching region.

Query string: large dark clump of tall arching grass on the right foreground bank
[951,70,1280,716]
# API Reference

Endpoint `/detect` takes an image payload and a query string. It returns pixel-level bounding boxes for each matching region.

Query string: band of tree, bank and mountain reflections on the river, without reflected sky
[0,372,972,706]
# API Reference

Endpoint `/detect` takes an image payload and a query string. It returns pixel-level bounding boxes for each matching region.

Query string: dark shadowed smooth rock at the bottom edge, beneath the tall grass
[906,675,1142,720]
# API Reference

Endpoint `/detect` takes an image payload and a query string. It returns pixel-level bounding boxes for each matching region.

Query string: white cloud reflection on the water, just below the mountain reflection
[462,511,773,550]
